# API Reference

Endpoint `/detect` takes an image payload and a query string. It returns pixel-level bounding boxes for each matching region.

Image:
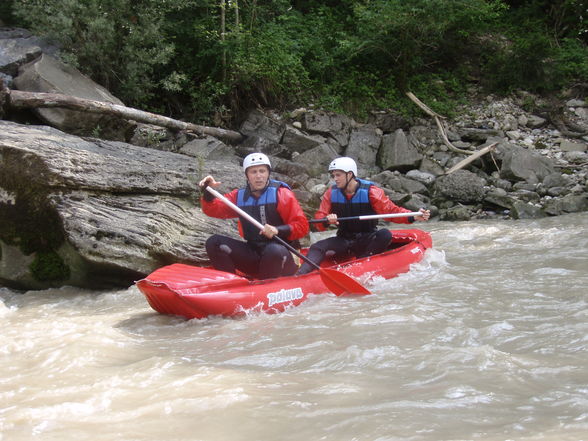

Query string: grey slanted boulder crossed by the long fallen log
[14,54,130,140]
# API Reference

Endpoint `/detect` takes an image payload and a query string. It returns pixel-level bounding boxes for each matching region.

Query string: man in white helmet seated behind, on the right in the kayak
[297,157,430,275]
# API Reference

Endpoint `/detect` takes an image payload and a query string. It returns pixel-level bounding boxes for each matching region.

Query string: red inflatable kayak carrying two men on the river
[136,230,432,319]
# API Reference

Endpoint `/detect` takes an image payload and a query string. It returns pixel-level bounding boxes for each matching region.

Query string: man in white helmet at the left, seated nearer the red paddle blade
[199,153,308,279]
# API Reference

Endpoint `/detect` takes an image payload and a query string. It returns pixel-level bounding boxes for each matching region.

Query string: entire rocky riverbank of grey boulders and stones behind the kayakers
[0,26,588,289]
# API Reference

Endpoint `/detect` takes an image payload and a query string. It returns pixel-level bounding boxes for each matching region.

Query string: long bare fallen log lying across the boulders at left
[0,81,243,144]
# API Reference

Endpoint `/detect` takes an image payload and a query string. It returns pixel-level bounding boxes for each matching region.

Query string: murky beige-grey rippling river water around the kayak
[0,213,588,441]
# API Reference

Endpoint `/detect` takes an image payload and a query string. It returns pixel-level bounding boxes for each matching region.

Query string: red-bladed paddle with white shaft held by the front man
[206,186,371,296]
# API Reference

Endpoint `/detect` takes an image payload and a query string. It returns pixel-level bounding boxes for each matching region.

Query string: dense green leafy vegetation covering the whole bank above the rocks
[5,0,588,124]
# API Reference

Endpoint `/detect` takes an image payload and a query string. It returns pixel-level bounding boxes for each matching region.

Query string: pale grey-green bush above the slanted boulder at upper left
[14,0,173,105]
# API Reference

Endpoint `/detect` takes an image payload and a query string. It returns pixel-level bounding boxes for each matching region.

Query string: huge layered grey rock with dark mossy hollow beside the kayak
[0,121,243,289]
